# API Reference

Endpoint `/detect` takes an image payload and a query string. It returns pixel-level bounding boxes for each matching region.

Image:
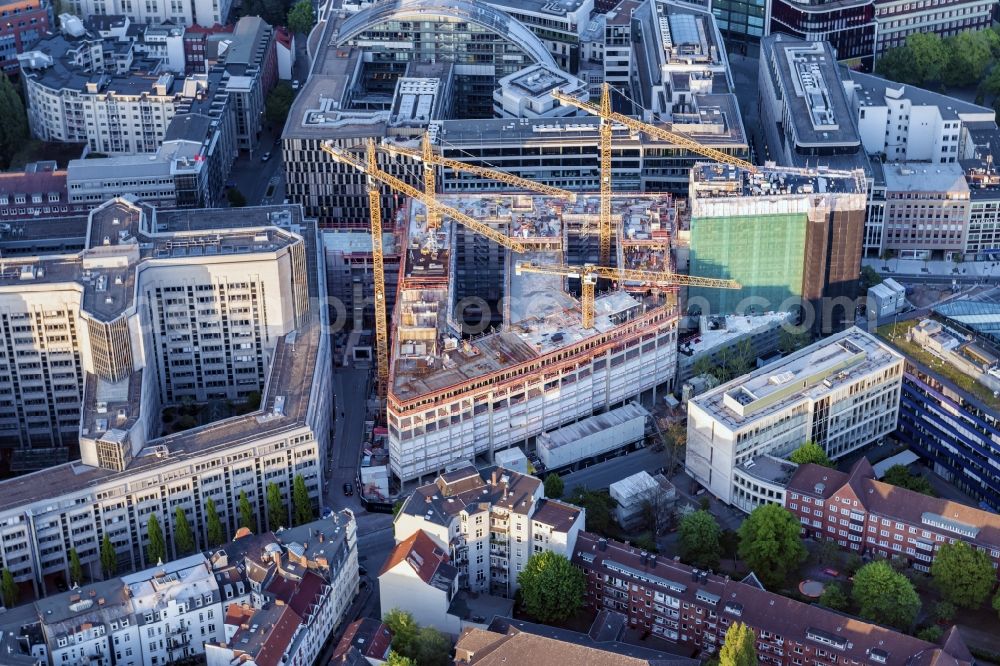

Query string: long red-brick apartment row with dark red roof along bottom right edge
[573,532,973,666]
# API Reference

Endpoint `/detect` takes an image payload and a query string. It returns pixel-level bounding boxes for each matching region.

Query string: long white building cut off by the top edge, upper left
[67,0,232,28]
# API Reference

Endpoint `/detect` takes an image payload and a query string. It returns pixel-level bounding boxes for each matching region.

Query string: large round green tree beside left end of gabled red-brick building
[739,504,806,586]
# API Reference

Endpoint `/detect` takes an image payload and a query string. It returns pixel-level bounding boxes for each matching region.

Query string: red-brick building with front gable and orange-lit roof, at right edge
[785,458,1000,571]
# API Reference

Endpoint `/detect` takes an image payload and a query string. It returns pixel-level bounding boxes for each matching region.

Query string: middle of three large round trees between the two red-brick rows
[851,560,920,629]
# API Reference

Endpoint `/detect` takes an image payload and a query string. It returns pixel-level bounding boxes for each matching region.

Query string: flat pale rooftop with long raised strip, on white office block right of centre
[691,328,903,430]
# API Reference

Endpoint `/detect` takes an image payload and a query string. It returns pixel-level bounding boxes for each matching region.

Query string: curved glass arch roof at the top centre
[337,0,558,69]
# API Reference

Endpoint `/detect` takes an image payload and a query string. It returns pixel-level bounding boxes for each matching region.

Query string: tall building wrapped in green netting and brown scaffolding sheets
[688,163,866,333]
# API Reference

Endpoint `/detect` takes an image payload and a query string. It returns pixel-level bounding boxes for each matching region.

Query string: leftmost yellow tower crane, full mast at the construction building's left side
[322,140,526,398]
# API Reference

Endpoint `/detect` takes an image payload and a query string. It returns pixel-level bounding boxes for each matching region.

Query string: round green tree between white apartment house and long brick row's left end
[517,550,587,622]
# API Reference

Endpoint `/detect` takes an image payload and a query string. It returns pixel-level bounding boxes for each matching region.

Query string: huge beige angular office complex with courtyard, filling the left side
[0,199,331,594]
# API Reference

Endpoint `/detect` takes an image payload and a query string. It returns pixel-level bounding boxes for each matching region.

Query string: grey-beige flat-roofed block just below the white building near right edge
[880,163,971,260]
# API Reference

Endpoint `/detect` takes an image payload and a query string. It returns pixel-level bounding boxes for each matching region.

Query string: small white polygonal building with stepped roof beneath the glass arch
[493,65,590,118]
